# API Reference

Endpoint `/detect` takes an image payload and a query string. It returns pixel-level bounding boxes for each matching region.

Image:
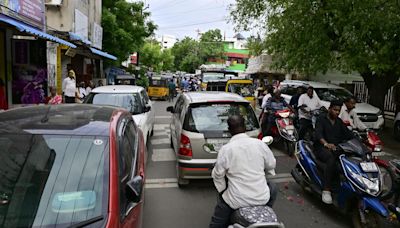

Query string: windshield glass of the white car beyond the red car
[85,93,143,114]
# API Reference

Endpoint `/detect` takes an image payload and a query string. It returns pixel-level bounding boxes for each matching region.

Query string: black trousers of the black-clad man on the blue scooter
[316,146,339,190]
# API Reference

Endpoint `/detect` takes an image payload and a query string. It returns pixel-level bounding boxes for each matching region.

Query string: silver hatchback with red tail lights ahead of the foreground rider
[167,91,262,187]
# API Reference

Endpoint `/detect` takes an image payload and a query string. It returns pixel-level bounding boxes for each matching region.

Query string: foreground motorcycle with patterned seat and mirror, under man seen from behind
[228,136,285,228]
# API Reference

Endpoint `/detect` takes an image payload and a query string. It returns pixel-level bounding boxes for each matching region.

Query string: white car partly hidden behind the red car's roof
[83,85,155,144]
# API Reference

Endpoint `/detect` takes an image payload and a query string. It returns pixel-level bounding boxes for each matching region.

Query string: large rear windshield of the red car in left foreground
[0,134,109,227]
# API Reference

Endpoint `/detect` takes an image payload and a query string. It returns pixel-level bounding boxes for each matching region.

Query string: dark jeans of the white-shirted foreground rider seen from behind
[209,181,278,228]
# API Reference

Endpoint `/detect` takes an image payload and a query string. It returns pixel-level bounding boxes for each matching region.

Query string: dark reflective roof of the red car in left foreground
[0,104,126,137]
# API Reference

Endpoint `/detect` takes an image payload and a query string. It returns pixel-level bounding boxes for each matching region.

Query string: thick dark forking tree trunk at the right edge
[361,72,399,112]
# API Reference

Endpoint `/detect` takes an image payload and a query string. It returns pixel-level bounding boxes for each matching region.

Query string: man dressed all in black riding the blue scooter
[315,100,354,204]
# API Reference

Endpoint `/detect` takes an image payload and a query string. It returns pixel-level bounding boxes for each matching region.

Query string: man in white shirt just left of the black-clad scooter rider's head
[297,86,322,139]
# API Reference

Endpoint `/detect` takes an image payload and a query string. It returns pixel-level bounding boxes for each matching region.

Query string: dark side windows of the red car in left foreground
[118,120,136,218]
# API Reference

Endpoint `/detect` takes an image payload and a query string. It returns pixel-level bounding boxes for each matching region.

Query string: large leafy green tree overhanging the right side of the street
[231,0,400,109]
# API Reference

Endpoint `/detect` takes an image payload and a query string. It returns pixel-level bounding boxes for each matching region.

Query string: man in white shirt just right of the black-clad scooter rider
[339,97,367,131]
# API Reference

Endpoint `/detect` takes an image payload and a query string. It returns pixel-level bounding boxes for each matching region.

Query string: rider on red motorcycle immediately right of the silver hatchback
[263,90,294,136]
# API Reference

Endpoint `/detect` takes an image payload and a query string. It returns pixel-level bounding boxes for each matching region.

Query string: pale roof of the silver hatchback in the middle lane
[183,91,248,103]
